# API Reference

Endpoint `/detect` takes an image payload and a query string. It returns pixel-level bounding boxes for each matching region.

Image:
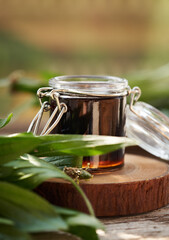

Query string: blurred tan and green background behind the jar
[0,0,169,132]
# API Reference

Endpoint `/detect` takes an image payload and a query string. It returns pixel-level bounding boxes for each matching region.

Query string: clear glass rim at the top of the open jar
[49,75,129,96]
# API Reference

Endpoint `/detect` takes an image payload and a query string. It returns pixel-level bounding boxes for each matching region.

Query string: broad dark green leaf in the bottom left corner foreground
[0,182,68,232]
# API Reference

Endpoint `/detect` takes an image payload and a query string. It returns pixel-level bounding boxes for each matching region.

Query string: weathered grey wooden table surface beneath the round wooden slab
[35,205,169,240]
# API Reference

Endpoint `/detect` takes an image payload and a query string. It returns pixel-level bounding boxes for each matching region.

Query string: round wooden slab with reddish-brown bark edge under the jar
[36,154,169,216]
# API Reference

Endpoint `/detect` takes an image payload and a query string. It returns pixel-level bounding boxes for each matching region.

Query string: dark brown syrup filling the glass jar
[51,95,126,172]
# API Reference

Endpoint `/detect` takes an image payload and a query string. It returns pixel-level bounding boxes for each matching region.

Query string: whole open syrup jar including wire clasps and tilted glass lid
[27,76,169,172]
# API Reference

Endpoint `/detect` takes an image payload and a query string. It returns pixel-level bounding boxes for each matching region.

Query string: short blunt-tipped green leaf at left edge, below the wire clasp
[0,133,41,164]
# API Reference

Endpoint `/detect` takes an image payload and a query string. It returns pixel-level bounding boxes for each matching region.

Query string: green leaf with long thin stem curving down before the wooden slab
[0,154,94,215]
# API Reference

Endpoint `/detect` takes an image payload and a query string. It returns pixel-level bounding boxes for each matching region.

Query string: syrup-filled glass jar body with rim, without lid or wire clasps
[49,76,129,172]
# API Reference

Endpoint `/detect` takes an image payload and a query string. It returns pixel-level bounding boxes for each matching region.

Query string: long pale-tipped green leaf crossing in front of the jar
[31,134,136,157]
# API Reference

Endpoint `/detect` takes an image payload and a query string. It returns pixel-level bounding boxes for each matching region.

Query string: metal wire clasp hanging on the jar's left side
[27,87,67,135]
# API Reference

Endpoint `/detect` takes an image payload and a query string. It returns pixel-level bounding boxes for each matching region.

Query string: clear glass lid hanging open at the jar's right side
[126,102,169,160]
